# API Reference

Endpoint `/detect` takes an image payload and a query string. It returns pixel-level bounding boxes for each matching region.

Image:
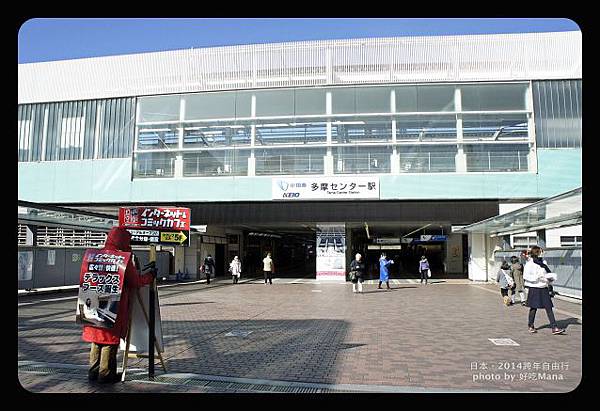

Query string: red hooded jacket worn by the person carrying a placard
[82,227,153,345]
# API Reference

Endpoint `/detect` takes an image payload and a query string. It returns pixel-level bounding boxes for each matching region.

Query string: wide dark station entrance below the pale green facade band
[58,200,499,280]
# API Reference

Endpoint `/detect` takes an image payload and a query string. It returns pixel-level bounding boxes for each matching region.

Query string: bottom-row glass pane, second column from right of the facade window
[398,145,457,173]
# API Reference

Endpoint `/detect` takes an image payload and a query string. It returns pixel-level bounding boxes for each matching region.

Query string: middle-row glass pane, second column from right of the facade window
[396,114,456,141]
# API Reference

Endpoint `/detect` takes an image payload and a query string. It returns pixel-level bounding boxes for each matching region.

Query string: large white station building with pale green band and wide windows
[18,32,582,281]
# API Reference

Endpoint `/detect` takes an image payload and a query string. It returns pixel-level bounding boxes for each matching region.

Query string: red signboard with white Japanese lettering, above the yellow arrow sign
[119,207,190,231]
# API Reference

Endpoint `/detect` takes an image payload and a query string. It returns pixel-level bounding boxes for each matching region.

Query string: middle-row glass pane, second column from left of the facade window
[183,124,251,148]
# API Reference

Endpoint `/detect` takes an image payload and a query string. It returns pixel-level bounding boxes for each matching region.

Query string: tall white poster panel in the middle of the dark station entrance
[317,223,346,282]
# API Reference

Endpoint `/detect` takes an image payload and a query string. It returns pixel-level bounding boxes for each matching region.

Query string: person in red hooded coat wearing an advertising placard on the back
[77,227,156,383]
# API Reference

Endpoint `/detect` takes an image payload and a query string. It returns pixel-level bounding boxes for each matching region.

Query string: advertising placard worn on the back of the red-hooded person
[75,250,131,328]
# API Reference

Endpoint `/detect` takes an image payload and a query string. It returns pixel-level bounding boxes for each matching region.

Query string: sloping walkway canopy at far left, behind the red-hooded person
[17,201,119,231]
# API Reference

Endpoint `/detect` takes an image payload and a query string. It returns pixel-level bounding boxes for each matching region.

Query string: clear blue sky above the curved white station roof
[18,18,579,63]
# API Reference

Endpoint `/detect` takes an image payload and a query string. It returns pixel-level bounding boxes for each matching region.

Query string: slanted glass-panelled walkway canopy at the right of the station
[455,187,583,237]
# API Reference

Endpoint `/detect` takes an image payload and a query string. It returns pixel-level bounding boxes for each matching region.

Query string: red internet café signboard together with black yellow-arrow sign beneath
[119,207,191,247]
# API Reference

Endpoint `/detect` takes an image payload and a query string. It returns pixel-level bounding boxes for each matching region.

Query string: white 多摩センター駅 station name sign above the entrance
[271,176,379,200]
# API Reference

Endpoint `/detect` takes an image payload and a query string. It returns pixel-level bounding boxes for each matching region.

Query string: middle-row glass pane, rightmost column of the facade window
[463,114,529,141]
